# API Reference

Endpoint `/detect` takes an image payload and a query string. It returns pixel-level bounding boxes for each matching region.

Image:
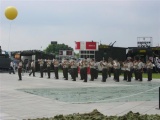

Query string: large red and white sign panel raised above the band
[75,41,98,50]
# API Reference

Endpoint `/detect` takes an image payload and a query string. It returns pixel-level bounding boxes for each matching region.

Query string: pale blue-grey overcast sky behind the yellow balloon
[0,0,160,51]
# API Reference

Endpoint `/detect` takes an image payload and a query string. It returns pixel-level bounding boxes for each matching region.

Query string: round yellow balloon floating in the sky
[5,6,18,20]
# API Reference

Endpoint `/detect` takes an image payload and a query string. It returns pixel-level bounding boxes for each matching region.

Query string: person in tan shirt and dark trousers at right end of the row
[146,60,153,81]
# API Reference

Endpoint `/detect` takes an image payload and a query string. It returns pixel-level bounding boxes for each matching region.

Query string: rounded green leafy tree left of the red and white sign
[44,44,73,55]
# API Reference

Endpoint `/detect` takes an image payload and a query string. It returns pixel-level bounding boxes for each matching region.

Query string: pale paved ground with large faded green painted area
[0,73,160,120]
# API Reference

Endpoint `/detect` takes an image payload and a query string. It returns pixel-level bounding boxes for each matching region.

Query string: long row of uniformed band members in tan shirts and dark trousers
[15,59,153,82]
